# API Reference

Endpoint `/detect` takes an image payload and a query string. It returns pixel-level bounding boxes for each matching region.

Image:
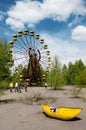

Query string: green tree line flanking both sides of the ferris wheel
[0,40,86,89]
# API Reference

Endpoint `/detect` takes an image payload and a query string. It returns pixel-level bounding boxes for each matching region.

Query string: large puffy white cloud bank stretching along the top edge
[6,0,86,28]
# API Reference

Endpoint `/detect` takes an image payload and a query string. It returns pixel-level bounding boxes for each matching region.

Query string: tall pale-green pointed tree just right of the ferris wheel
[48,56,64,89]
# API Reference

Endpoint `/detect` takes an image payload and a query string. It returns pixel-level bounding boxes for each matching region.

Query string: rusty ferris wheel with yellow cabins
[9,29,51,84]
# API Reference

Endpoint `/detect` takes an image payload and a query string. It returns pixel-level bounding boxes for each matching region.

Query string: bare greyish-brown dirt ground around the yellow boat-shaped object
[0,86,86,130]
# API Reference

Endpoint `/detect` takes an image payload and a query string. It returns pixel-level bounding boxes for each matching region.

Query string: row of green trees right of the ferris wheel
[47,56,86,89]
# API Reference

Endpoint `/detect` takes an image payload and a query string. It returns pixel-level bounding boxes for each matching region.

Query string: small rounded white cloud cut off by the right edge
[72,25,86,41]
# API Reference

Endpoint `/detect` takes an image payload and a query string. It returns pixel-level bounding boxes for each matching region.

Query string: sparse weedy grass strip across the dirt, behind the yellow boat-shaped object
[0,92,56,105]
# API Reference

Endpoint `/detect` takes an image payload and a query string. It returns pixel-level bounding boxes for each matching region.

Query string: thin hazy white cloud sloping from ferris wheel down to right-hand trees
[41,33,86,64]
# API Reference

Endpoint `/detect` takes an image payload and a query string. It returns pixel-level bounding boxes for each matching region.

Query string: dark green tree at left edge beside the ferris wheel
[0,40,12,86]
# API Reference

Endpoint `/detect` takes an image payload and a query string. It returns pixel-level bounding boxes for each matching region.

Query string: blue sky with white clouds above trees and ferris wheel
[0,0,86,65]
